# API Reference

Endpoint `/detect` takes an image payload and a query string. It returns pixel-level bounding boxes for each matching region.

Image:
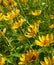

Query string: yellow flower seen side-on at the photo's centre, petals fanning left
[25,20,40,38]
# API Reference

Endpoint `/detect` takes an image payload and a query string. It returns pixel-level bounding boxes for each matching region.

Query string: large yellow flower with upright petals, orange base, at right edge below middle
[35,34,54,46]
